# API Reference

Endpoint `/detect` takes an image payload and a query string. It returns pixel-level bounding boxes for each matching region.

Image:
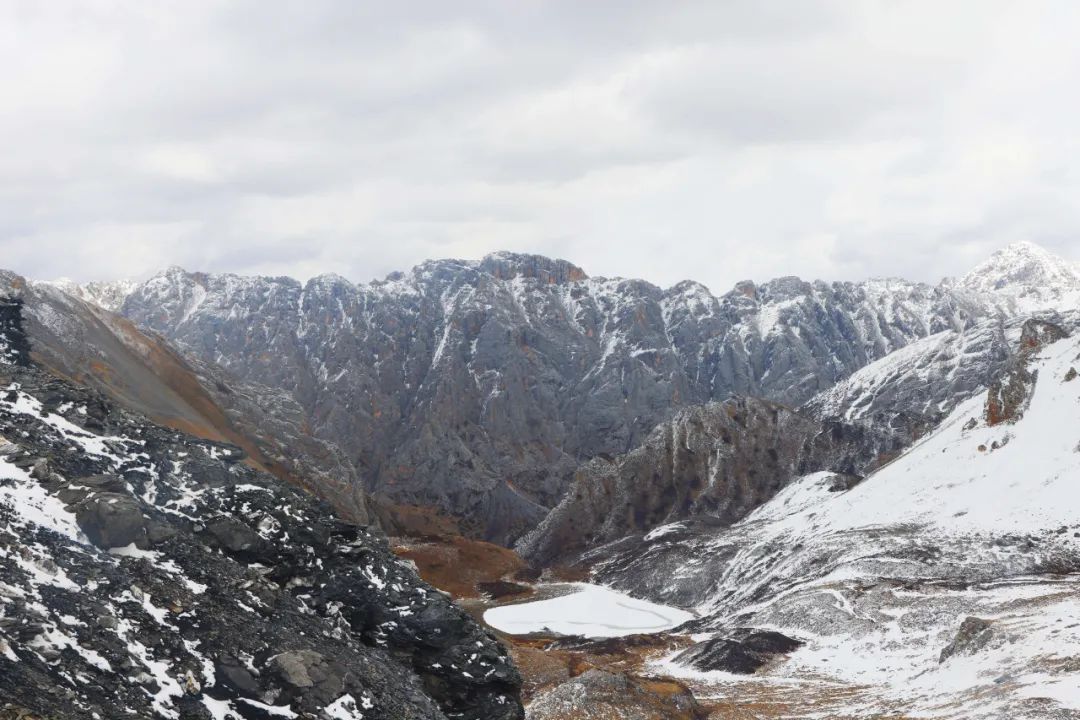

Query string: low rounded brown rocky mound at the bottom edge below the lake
[526,669,707,720]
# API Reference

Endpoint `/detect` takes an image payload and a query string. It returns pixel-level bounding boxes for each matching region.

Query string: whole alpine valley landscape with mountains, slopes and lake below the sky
[0,243,1080,720]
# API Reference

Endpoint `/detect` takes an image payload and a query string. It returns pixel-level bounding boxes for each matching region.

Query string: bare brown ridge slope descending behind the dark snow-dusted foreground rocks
[0,271,370,522]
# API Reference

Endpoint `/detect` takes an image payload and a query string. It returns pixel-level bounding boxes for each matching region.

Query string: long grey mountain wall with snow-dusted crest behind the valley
[116,254,1011,542]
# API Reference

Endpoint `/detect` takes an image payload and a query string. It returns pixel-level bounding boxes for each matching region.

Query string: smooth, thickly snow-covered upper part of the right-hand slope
[768,332,1080,539]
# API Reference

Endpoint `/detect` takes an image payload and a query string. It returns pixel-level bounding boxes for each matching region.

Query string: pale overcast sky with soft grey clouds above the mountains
[0,0,1080,293]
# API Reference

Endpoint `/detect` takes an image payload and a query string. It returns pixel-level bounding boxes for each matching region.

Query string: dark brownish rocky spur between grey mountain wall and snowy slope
[515,398,900,565]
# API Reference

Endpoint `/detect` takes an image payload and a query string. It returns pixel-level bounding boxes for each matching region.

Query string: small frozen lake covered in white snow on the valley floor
[484,583,693,638]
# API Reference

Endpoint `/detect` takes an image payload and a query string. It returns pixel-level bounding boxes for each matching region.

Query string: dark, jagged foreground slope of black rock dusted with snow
[0,343,523,720]
